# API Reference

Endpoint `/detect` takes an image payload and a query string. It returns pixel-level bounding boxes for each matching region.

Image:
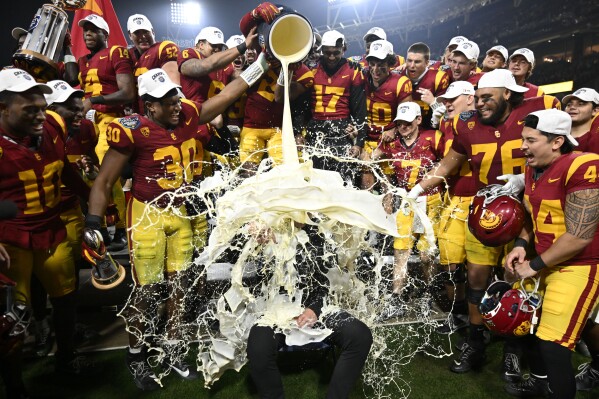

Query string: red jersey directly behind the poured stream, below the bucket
[243,64,314,129]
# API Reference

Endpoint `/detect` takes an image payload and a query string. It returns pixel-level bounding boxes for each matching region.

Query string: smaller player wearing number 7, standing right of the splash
[373,102,443,319]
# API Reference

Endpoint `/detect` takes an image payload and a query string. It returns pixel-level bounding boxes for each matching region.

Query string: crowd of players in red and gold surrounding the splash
[0,3,599,398]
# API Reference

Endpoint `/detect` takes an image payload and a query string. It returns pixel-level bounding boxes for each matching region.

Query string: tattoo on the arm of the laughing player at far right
[565,189,599,240]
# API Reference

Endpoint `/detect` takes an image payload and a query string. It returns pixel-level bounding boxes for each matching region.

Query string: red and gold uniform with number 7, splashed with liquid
[381,130,442,251]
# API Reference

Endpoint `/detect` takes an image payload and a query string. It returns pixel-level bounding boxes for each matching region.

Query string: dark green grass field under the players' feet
[15,326,599,399]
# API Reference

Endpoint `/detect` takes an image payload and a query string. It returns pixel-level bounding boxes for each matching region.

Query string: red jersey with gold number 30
[106,99,200,206]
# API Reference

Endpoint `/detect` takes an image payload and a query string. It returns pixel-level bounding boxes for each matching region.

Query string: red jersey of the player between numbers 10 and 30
[60,119,98,210]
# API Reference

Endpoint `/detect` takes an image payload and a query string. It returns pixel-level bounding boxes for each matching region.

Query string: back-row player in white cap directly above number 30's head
[127,14,180,114]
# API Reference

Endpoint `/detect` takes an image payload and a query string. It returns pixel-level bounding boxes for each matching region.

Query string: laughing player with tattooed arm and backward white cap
[505,110,599,399]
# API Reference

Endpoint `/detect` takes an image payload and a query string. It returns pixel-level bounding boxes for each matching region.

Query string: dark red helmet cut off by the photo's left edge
[0,273,30,355]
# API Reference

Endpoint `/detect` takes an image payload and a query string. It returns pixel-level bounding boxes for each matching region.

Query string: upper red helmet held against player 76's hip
[468,184,524,247]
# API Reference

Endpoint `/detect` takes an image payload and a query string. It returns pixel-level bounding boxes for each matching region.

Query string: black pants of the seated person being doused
[247,312,372,399]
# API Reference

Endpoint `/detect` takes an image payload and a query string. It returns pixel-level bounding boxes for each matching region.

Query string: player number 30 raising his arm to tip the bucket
[85,61,267,390]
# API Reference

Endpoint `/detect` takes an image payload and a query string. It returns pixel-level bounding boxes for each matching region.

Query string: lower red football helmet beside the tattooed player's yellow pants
[478,278,542,337]
